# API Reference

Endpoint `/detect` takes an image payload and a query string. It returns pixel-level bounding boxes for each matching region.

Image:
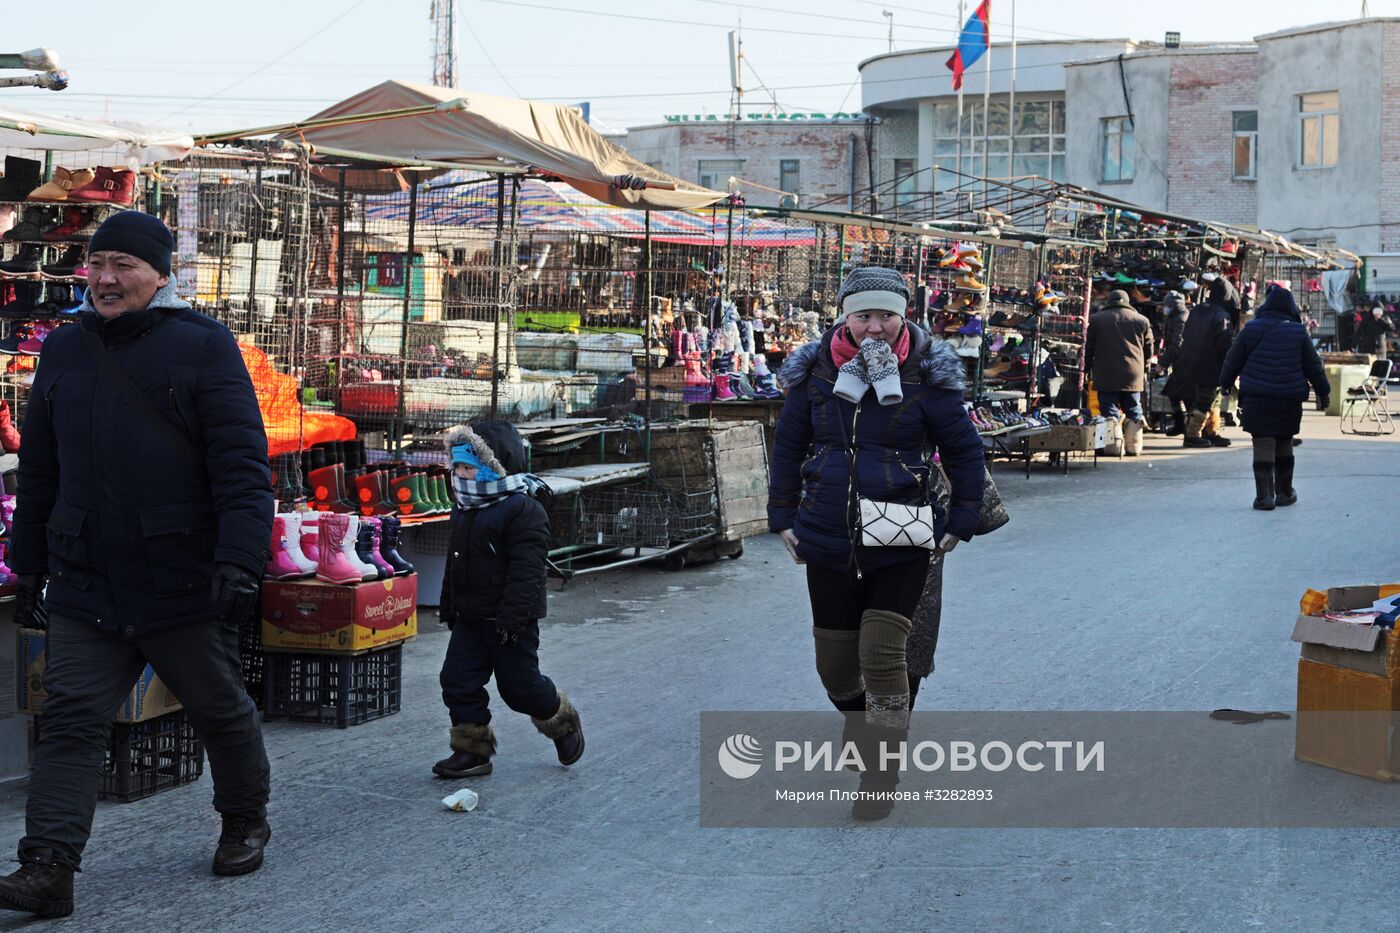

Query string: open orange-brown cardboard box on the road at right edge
[1292,584,1400,780]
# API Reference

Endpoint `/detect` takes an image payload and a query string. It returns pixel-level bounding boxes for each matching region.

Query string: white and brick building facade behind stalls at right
[860,17,1400,261]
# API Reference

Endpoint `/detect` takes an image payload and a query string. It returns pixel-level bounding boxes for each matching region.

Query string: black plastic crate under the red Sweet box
[263,644,403,728]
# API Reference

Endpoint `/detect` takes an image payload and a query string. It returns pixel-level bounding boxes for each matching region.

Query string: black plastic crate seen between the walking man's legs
[98,710,204,803]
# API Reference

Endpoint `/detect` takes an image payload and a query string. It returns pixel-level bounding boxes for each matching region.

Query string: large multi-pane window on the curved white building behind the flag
[932,98,1065,191]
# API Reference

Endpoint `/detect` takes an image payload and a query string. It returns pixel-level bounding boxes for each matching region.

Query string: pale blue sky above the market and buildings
[0,0,1400,132]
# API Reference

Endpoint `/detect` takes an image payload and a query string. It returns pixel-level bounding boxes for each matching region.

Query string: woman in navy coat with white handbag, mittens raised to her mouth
[769,268,986,820]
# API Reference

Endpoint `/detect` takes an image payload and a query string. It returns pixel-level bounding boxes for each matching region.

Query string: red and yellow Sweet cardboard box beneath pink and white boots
[262,573,419,653]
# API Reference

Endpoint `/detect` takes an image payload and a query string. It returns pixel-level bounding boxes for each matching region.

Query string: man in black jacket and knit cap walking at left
[0,212,274,916]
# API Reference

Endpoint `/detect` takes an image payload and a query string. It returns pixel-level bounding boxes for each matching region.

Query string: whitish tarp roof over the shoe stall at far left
[0,106,195,170]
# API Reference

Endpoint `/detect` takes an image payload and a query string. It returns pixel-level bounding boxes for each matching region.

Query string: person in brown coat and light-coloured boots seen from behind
[1084,291,1156,457]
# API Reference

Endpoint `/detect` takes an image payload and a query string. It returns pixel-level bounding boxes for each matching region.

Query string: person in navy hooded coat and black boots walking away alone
[1219,286,1331,511]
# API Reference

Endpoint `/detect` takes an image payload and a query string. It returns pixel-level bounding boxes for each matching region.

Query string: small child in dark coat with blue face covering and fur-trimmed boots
[433,420,584,778]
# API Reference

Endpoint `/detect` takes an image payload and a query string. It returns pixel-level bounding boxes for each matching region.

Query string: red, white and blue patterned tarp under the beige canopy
[365,172,816,247]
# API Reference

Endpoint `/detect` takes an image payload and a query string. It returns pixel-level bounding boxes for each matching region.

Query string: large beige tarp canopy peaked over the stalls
[281,81,727,210]
